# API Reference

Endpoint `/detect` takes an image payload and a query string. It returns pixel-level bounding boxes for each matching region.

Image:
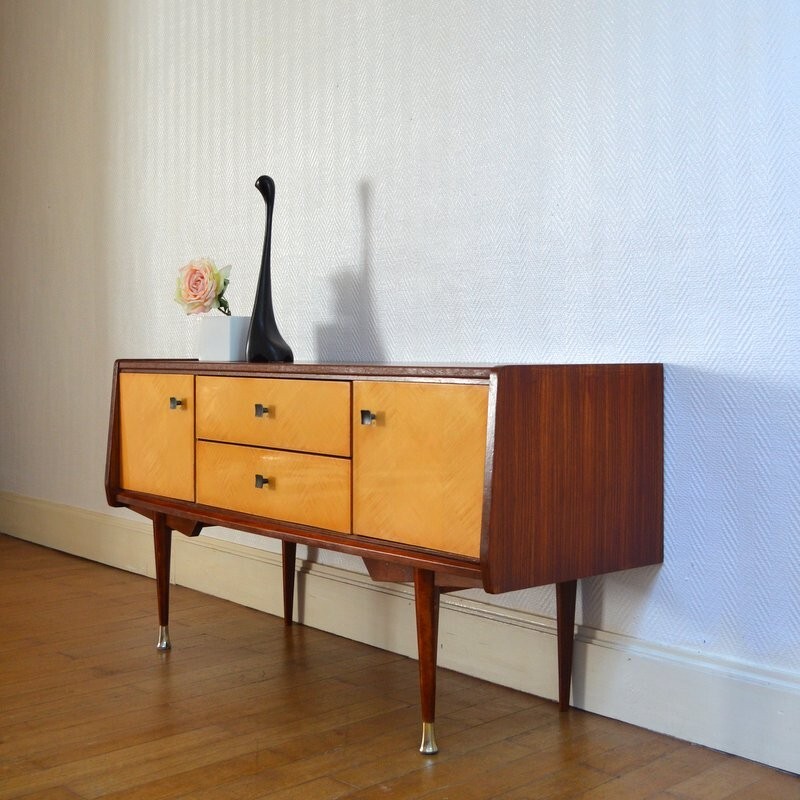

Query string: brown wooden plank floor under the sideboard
[0,535,800,800]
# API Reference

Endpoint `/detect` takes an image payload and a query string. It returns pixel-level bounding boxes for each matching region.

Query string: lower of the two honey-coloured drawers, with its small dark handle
[197,441,350,533]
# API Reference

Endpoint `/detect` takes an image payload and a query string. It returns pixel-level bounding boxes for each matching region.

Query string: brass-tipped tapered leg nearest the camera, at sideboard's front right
[414,569,439,754]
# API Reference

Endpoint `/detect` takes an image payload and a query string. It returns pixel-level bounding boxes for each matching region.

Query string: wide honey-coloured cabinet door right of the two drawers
[353,381,489,558]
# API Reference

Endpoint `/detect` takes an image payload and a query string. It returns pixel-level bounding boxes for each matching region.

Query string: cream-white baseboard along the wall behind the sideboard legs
[0,492,800,773]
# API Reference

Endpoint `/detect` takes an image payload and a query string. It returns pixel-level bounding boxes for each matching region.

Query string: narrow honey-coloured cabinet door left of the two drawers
[119,372,194,500]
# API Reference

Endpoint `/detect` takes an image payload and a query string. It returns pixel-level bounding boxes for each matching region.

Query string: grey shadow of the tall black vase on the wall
[314,180,386,363]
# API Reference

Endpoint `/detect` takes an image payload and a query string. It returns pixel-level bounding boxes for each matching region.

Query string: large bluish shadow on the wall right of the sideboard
[573,357,800,703]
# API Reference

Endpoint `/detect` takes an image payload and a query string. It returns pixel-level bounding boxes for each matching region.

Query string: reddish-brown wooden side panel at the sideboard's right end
[482,364,663,592]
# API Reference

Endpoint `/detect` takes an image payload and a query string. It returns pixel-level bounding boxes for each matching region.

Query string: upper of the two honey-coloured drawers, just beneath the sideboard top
[195,375,350,456]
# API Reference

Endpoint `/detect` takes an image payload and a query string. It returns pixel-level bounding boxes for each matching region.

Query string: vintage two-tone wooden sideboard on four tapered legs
[106,360,663,753]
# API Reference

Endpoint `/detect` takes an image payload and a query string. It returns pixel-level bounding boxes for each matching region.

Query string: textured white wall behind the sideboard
[0,0,800,684]
